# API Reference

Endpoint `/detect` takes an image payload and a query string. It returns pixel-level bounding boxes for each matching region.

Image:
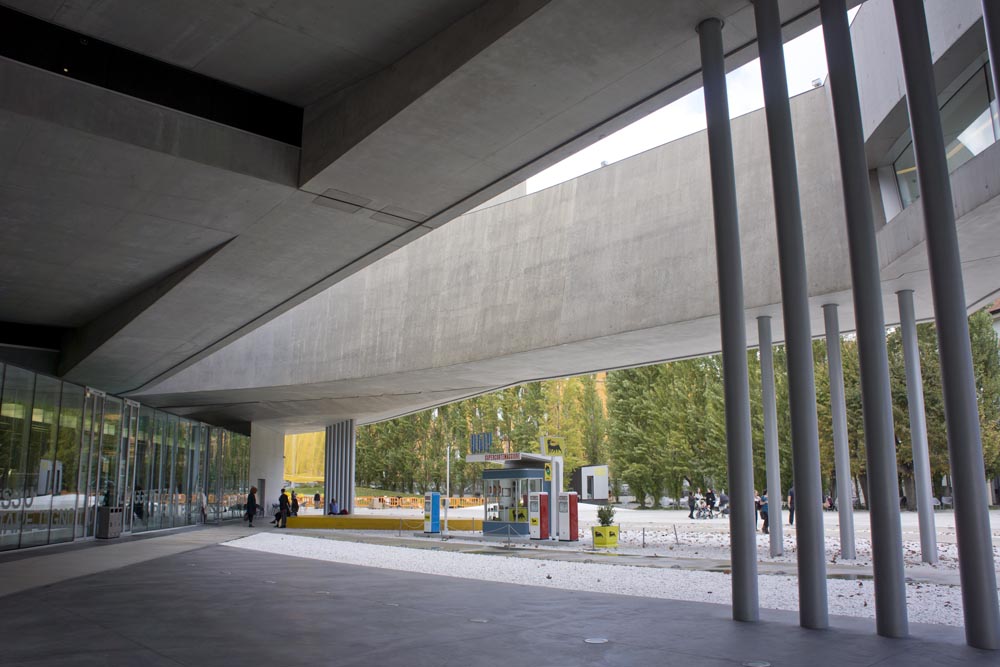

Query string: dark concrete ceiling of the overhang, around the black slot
[0,0,852,408]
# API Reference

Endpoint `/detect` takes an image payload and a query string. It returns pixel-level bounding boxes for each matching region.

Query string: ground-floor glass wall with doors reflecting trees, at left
[0,363,250,551]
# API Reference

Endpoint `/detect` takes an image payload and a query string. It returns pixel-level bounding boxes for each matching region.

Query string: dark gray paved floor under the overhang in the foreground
[0,525,1000,667]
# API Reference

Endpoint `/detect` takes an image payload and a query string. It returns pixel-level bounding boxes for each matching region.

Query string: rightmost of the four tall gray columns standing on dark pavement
[893,0,1000,649]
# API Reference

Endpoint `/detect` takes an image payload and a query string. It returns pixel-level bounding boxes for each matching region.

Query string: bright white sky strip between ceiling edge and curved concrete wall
[528,8,858,194]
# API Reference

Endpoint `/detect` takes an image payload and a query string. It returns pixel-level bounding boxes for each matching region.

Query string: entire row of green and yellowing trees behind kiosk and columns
[357,311,1000,506]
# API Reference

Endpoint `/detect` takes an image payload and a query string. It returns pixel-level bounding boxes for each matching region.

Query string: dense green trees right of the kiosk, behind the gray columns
[608,311,1000,506]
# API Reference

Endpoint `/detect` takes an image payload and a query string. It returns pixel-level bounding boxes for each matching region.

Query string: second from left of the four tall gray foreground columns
[754,0,830,628]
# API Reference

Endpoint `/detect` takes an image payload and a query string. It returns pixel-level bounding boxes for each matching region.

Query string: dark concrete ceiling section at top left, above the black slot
[2,0,485,106]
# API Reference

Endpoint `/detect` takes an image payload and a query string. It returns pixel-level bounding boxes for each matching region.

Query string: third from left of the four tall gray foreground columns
[819,0,919,637]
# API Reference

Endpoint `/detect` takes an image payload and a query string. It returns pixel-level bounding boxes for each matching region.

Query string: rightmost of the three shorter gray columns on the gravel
[896,290,937,563]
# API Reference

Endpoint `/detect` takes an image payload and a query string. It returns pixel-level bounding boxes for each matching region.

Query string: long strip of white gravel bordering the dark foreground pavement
[226,533,963,626]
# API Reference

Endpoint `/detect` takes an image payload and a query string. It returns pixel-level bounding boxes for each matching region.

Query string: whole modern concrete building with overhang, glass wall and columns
[0,0,1000,649]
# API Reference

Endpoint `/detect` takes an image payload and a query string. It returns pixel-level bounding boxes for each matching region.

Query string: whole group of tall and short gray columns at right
[698,0,1000,649]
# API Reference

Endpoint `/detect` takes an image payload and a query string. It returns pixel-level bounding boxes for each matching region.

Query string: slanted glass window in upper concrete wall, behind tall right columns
[892,62,1000,208]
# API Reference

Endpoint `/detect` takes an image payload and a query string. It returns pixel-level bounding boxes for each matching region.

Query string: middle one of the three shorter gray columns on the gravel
[823,303,857,560]
